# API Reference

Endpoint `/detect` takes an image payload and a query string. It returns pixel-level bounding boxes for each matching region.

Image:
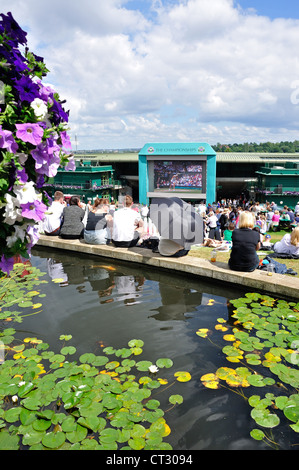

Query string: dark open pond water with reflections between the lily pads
[11,248,298,451]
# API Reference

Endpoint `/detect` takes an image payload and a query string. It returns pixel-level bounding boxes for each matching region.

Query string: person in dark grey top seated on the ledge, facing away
[60,196,85,240]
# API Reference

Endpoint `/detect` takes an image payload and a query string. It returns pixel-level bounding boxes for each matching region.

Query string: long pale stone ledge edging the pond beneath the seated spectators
[37,235,299,301]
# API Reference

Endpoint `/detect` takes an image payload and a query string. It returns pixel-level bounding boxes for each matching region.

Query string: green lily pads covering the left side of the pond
[0,265,191,450]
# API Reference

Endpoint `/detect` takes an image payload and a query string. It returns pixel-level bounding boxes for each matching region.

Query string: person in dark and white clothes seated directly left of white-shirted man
[84,198,113,245]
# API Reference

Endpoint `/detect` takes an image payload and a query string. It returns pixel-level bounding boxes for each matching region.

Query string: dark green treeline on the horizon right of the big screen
[212,140,299,153]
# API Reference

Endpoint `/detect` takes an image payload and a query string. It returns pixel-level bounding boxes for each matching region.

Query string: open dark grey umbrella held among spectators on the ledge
[149,197,203,250]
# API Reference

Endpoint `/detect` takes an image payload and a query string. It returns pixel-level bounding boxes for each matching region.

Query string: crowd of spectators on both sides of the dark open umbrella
[41,191,299,272]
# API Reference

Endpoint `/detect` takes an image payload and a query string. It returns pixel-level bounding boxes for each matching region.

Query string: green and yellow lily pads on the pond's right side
[197,293,299,446]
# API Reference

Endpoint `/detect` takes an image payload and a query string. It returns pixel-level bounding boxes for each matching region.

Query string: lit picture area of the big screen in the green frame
[154,161,203,193]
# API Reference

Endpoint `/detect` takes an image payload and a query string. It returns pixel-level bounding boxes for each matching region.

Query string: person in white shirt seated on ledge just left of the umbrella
[112,195,143,248]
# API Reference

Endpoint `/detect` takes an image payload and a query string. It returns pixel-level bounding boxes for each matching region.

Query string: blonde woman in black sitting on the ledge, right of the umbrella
[228,211,260,272]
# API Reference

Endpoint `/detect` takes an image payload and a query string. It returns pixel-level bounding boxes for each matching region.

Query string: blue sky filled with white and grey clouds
[0,0,299,150]
